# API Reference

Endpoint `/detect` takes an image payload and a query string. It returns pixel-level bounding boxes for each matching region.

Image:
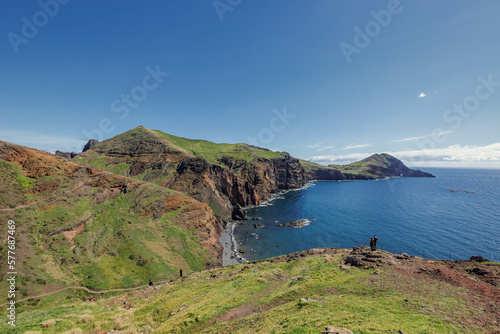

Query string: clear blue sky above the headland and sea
[0,0,500,168]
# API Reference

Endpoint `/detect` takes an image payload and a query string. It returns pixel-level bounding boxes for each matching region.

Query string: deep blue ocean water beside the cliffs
[234,168,500,262]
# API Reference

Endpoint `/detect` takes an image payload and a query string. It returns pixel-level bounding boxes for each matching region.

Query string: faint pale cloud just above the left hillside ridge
[0,129,86,153]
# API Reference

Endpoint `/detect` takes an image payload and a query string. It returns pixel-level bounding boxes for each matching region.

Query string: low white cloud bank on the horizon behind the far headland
[308,143,500,169]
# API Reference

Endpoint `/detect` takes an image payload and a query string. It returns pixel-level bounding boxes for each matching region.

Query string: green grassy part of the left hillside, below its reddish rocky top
[0,160,211,301]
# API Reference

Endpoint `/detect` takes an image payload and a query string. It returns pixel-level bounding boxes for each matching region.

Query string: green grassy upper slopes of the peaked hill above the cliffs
[74,127,288,198]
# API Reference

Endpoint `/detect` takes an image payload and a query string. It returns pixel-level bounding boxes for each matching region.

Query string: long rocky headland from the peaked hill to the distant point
[70,126,432,268]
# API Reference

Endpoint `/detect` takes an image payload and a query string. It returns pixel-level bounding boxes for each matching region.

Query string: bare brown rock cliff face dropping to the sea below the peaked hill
[168,155,307,219]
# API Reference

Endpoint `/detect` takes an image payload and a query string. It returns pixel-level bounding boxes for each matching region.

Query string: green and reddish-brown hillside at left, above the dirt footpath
[0,142,221,302]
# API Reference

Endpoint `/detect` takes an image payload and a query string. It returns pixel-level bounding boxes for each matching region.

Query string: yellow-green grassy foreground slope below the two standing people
[13,254,494,334]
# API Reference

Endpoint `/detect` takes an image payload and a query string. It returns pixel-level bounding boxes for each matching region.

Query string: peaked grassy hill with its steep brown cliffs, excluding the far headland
[75,127,308,220]
